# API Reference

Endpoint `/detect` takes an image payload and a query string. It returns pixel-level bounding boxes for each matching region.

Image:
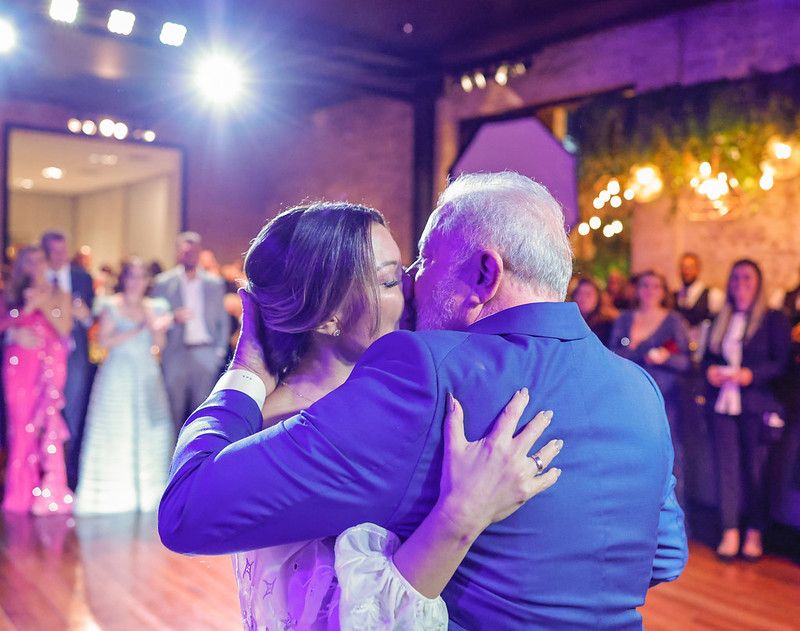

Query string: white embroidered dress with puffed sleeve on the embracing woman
[233,524,448,631]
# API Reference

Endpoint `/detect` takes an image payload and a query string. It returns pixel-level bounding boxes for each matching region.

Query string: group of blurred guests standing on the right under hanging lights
[570,253,800,561]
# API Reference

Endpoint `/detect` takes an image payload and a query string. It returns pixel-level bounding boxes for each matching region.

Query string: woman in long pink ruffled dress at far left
[0,246,73,515]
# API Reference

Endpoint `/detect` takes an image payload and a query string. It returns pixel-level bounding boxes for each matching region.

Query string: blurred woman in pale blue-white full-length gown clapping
[75,259,174,514]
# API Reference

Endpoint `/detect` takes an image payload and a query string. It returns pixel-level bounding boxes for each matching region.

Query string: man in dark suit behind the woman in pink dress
[42,232,94,490]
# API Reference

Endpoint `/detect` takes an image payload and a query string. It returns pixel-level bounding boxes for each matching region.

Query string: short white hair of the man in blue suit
[422,171,572,300]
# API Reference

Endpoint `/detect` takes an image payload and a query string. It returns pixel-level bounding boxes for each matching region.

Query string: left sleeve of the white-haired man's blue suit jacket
[158,332,440,554]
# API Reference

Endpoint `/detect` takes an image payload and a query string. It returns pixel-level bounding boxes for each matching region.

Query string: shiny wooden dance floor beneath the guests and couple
[0,515,800,631]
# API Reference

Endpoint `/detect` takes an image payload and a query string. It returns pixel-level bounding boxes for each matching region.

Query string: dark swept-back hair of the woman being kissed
[244,202,385,378]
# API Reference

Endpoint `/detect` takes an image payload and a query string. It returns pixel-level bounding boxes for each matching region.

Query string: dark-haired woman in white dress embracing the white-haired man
[233,203,561,631]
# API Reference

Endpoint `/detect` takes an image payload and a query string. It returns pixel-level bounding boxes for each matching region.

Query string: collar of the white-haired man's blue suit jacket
[467,302,591,340]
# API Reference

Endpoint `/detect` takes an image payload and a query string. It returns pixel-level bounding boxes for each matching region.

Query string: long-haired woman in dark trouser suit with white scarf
[705,259,790,561]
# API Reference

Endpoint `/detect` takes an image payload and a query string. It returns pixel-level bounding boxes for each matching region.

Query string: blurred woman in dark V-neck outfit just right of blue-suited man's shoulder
[609,270,690,504]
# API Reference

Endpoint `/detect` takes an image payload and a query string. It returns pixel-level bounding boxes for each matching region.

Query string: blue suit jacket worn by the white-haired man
[159,303,687,630]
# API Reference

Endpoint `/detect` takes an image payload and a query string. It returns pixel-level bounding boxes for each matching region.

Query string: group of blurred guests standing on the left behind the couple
[0,232,237,515]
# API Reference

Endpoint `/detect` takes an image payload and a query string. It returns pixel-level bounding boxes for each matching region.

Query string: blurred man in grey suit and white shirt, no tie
[153,232,230,423]
